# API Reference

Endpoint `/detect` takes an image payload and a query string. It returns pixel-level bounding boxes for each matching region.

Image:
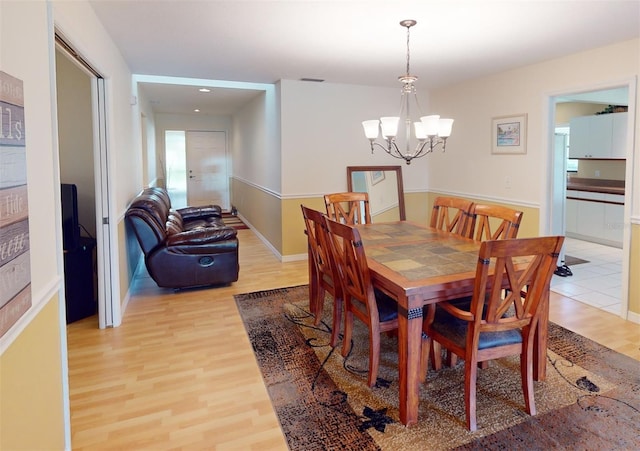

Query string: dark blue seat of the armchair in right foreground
[431,308,522,349]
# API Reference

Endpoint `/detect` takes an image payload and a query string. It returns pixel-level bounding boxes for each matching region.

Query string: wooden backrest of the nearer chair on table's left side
[325,217,380,323]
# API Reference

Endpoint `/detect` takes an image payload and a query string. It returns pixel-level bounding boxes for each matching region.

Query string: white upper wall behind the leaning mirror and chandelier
[281,80,431,197]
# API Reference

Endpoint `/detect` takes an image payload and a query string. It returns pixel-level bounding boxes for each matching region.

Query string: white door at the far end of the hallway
[186,131,231,210]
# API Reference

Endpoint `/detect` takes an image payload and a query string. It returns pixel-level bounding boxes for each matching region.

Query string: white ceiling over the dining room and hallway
[90,0,640,114]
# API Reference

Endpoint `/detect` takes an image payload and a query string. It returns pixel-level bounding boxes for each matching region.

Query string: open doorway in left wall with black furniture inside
[55,32,121,328]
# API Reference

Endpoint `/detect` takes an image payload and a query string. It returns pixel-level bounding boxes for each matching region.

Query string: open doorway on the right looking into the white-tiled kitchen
[547,83,633,317]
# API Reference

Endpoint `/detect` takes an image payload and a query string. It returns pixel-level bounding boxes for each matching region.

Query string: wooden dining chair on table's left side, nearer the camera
[325,218,398,387]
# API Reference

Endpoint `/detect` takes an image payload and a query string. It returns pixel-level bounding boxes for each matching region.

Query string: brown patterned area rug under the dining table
[235,285,640,451]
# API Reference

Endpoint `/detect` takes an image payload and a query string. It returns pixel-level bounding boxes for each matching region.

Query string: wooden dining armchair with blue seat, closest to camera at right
[422,236,564,431]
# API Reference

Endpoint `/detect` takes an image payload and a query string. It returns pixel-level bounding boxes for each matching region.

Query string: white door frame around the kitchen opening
[540,76,640,320]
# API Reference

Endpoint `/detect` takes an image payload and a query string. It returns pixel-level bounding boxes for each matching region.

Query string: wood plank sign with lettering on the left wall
[0,71,31,337]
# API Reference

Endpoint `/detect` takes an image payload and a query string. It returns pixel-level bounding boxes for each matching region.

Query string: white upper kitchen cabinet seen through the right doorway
[569,113,627,159]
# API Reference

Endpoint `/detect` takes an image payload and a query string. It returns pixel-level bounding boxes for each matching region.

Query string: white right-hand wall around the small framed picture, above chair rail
[428,40,639,214]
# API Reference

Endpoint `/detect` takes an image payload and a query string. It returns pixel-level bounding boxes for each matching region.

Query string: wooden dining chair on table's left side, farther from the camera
[300,205,343,347]
